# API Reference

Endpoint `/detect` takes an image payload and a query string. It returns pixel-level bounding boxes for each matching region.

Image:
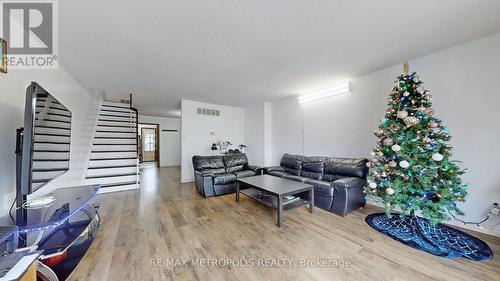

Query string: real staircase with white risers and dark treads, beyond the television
[86,101,139,193]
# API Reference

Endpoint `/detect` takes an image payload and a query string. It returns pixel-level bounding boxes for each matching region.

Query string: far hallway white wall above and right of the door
[139,115,181,167]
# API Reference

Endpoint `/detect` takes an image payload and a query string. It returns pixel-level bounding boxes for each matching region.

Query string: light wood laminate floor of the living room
[70,167,500,281]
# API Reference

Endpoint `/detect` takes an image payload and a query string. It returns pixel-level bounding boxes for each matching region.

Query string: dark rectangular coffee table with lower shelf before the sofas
[236,175,314,227]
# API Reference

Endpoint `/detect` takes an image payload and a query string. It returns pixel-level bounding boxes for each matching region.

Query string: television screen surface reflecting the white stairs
[31,93,71,191]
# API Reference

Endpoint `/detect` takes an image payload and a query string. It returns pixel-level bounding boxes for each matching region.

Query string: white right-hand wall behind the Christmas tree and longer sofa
[272,34,500,233]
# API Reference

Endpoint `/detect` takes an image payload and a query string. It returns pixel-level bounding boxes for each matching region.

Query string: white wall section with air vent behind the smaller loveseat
[181,100,245,182]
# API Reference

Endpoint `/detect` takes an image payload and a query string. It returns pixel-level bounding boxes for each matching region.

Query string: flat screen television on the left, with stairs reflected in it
[16,82,72,225]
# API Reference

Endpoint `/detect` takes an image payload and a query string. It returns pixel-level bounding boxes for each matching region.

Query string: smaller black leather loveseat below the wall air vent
[193,153,261,197]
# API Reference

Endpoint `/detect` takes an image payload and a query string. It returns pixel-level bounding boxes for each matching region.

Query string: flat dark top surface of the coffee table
[238,175,314,195]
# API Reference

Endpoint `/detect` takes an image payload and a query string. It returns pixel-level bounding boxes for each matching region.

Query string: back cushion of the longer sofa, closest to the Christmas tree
[323,157,368,181]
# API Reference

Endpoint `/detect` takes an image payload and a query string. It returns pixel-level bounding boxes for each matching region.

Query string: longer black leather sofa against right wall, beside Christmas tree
[263,154,368,216]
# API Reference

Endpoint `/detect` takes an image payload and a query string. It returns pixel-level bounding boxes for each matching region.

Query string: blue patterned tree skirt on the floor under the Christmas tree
[365,213,493,261]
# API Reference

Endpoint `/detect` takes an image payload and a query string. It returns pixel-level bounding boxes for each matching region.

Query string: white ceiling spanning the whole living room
[59,0,500,117]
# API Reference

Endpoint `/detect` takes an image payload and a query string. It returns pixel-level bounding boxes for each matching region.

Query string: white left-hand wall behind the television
[0,67,100,221]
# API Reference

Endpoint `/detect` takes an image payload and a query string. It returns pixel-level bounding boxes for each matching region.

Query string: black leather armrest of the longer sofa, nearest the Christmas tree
[331,177,366,216]
